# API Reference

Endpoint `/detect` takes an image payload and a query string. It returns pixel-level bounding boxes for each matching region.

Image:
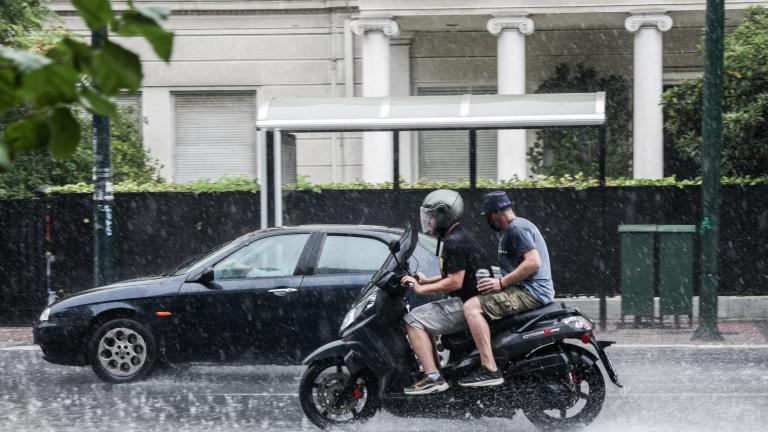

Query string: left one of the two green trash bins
[619,225,657,322]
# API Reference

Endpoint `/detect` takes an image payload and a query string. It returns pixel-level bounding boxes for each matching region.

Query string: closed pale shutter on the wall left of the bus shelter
[174,92,257,183]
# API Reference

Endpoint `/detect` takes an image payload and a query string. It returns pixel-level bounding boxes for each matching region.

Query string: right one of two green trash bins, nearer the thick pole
[656,225,696,325]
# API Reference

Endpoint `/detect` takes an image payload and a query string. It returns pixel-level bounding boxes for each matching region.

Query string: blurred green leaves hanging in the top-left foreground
[0,0,173,169]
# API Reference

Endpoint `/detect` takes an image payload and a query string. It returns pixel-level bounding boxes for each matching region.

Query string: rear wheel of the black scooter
[523,344,605,430]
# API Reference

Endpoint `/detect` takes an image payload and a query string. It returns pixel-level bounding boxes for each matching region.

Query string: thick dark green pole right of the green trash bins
[692,0,725,340]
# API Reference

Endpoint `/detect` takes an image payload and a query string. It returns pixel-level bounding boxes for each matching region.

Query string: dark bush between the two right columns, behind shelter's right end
[528,63,632,177]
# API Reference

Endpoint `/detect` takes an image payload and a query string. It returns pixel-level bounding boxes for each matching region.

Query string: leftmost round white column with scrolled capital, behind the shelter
[351,17,400,183]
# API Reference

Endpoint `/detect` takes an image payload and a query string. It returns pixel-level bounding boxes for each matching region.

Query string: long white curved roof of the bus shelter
[256,92,605,132]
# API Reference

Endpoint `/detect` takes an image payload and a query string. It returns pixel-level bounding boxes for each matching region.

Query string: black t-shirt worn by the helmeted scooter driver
[440,226,493,302]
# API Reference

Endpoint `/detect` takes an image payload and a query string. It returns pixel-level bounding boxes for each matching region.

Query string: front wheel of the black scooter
[299,358,381,429]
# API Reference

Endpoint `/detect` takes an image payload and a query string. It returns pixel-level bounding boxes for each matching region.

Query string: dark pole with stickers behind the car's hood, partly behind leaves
[91,26,114,286]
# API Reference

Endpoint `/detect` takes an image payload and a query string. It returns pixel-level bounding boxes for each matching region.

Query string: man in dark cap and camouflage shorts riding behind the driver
[459,191,555,387]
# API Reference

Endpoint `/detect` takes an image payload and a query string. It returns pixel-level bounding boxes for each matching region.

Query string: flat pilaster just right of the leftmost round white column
[389,35,414,182]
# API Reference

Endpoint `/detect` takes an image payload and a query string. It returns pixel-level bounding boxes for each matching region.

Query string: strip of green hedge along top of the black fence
[39,174,768,197]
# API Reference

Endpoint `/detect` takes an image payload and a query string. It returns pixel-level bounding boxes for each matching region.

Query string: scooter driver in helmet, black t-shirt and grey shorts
[401,189,490,394]
